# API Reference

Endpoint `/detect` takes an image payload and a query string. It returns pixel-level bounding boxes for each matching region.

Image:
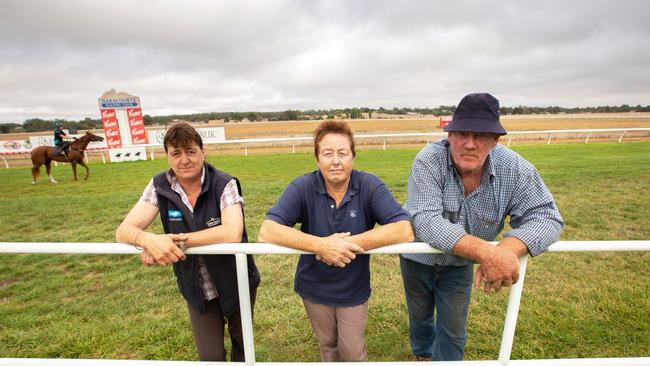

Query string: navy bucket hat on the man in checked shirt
[444,93,508,135]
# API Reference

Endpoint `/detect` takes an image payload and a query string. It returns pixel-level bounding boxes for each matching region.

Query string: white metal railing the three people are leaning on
[0,240,650,366]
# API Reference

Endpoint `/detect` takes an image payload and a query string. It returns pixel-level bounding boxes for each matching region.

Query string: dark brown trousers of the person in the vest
[187,289,257,362]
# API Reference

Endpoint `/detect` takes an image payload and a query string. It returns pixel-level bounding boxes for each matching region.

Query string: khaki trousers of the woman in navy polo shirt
[302,299,368,362]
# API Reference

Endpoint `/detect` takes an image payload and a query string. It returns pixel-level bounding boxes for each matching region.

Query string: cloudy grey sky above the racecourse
[0,0,650,123]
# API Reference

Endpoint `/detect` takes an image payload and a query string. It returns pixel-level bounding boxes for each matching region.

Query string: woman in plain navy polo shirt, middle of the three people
[258,121,413,362]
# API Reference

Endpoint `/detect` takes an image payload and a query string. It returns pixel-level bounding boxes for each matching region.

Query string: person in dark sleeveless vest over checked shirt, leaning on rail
[116,123,260,362]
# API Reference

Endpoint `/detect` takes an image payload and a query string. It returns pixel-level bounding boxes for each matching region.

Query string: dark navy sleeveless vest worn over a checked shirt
[153,163,260,316]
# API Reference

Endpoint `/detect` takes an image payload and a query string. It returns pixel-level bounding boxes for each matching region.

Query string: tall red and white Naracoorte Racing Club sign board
[98,89,147,162]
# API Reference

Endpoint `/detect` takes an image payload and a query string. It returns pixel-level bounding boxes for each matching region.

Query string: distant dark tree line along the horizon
[0,104,650,133]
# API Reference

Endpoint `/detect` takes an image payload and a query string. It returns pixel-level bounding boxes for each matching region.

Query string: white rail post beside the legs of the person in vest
[235,253,255,366]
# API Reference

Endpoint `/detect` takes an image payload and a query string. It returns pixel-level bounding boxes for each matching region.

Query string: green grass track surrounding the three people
[0,142,650,361]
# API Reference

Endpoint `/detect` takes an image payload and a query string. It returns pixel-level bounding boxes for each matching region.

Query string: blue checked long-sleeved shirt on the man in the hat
[403,138,563,266]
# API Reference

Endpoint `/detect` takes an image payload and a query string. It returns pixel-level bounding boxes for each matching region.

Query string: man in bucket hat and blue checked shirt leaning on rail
[400,93,563,361]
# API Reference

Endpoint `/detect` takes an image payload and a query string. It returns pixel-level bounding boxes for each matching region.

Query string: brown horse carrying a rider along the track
[32,132,104,184]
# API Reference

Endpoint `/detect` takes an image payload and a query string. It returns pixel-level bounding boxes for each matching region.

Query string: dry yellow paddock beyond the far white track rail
[5,113,650,167]
